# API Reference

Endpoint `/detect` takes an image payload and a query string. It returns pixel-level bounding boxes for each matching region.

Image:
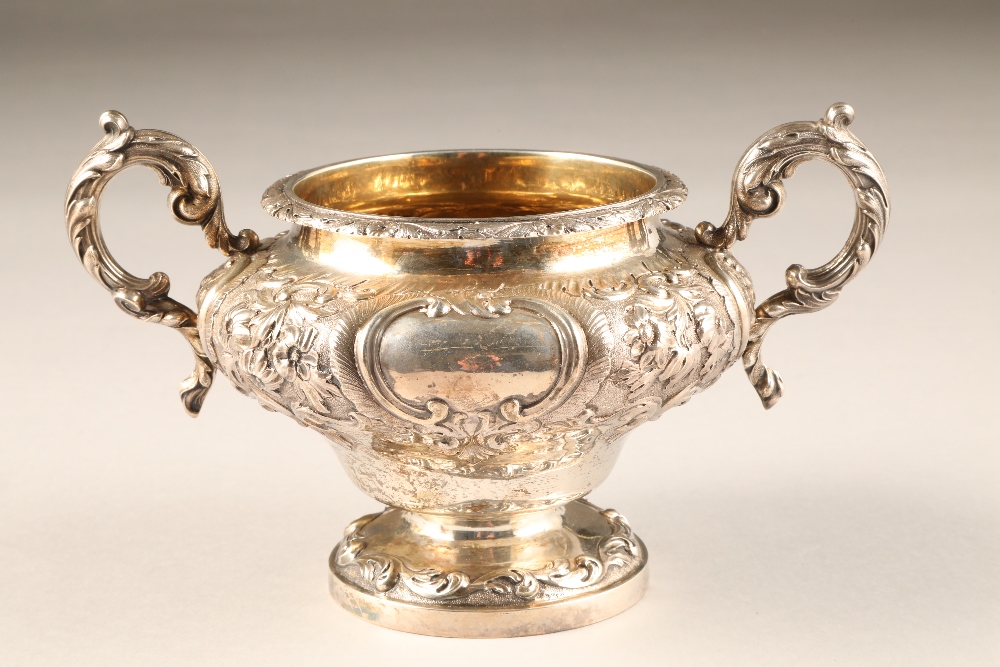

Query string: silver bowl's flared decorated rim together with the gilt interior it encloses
[261,150,687,239]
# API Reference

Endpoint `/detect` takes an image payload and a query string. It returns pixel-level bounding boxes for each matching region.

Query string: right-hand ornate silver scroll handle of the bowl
[696,104,889,408]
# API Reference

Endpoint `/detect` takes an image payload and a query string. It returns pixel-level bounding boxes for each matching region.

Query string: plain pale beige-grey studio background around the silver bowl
[0,1,1000,666]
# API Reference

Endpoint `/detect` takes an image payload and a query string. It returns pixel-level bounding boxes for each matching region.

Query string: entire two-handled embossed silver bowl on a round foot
[66,105,888,636]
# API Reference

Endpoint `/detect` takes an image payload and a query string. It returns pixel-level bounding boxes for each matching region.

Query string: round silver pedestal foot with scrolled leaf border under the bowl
[330,501,647,637]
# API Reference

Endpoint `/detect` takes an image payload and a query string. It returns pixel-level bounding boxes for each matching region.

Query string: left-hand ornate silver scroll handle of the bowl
[66,111,258,416]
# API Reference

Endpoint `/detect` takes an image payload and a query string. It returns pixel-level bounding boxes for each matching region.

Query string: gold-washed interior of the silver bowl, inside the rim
[294,151,656,219]
